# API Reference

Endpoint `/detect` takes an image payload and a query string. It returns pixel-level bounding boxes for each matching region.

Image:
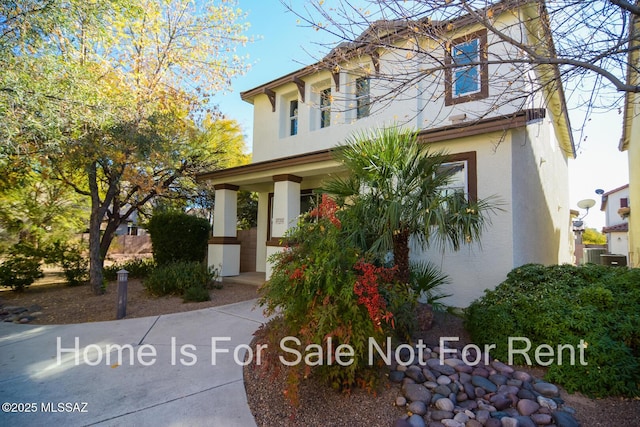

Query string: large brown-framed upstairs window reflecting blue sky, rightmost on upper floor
[445,31,489,105]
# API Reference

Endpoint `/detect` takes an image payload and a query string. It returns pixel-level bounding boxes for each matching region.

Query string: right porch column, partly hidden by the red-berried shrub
[265,174,302,280]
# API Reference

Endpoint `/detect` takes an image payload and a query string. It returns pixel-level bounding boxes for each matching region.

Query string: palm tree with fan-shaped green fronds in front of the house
[324,127,496,282]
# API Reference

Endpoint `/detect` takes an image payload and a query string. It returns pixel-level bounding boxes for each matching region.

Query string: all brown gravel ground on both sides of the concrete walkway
[0,280,640,427]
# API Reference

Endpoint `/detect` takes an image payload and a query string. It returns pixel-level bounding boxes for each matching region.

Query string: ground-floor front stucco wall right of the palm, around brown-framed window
[411,132,514,307]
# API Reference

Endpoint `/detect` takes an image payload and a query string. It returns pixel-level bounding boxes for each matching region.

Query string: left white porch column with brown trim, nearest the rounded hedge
[207,184,240,277]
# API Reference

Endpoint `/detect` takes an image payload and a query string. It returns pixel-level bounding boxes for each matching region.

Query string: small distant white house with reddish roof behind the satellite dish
[600,184,630,259]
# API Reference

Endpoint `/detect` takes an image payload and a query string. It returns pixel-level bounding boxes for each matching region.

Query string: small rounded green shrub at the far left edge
[0,245,44,292]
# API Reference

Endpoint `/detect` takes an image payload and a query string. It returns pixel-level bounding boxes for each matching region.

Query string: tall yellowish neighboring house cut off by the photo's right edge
[618,14,640,267]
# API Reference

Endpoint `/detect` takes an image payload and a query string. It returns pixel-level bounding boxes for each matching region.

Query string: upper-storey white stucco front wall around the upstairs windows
[252,14,531,163]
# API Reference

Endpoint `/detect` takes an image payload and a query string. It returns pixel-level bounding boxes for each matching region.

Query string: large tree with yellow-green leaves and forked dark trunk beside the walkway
[0,0,247,293]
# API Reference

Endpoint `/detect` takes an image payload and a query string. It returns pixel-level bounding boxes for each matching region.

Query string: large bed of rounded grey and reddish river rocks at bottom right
[389,343,580,427]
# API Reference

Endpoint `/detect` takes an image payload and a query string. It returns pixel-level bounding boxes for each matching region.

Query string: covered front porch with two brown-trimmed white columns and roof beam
[197,150,342,282]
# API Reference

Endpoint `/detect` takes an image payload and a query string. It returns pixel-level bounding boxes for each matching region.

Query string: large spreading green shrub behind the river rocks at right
[465,264,640,397]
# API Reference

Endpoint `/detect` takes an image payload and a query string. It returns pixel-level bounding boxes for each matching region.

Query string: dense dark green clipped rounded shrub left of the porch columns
[147,211,211,265]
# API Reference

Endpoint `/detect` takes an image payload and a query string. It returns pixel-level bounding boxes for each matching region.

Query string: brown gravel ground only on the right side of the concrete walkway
[244,313,640,427]
